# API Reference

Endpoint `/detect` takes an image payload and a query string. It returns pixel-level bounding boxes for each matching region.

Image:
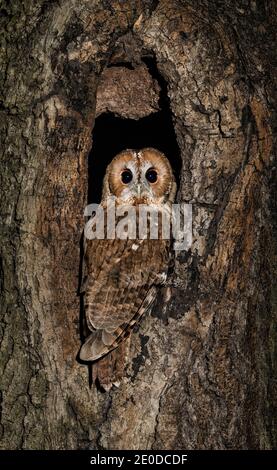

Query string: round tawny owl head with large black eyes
[102,148,176,205]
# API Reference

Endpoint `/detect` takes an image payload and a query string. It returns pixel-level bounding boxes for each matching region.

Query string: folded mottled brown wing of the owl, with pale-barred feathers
[80,239,168,361]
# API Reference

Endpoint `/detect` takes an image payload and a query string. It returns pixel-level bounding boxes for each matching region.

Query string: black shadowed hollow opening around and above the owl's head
[88,57,181,203]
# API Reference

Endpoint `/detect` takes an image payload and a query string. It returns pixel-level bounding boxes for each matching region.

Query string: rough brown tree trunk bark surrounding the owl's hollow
[0,0,277,449]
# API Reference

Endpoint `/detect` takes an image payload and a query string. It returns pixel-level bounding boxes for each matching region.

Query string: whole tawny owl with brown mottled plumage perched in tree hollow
[80,148,176,390]
